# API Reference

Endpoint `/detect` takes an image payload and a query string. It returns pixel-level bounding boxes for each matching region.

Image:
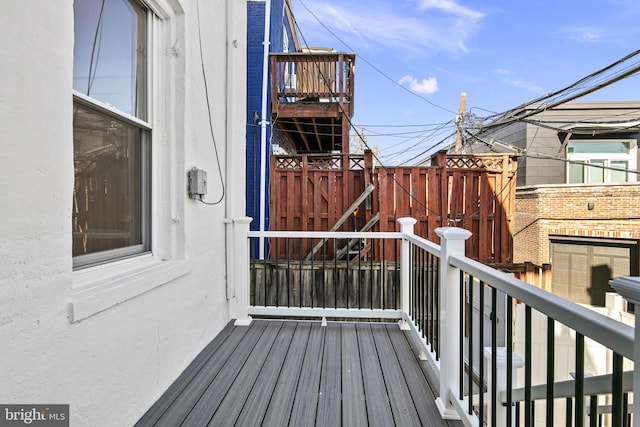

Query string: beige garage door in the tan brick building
[550,237,638,306]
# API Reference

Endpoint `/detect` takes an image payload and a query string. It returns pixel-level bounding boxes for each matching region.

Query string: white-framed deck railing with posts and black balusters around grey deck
[234,218,640,427]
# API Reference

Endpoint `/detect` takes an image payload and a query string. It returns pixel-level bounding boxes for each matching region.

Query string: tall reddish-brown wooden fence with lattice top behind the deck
[270,152,517,263]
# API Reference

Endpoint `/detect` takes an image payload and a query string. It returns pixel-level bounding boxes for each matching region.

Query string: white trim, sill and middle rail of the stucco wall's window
[67,0,192,322]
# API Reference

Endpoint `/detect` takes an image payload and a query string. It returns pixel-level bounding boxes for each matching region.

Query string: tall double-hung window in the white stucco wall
[72,0,151,267]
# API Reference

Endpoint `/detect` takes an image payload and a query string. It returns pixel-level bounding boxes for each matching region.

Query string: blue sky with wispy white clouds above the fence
[291,0,640,165]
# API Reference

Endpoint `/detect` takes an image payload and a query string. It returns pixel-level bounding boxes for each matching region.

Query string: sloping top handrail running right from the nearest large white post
[450,256,634,360]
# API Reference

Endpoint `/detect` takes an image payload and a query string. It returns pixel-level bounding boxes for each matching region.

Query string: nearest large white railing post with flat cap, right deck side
[435,227,471,419]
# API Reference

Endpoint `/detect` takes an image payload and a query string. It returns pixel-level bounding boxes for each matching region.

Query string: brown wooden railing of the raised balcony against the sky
[271,52,355,117]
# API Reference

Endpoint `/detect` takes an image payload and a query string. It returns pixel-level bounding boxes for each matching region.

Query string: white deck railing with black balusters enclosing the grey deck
[234,218,640,427]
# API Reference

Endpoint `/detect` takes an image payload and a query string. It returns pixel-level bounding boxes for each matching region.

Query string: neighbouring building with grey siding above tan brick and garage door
[471,102,640,306]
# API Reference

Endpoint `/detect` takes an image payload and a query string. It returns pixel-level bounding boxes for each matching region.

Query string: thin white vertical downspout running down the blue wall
[259,0,271,259]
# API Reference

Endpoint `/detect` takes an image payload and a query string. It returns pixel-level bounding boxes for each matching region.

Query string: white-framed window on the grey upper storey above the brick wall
[567,140,637,184]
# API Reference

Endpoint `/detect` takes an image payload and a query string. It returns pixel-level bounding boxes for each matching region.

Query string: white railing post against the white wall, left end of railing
[232,217,252,326]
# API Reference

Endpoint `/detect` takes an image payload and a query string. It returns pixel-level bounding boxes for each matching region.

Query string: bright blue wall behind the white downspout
[246,0,294,234]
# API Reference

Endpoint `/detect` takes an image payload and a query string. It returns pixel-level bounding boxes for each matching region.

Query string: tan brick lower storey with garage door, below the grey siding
[513,183,640,305]
